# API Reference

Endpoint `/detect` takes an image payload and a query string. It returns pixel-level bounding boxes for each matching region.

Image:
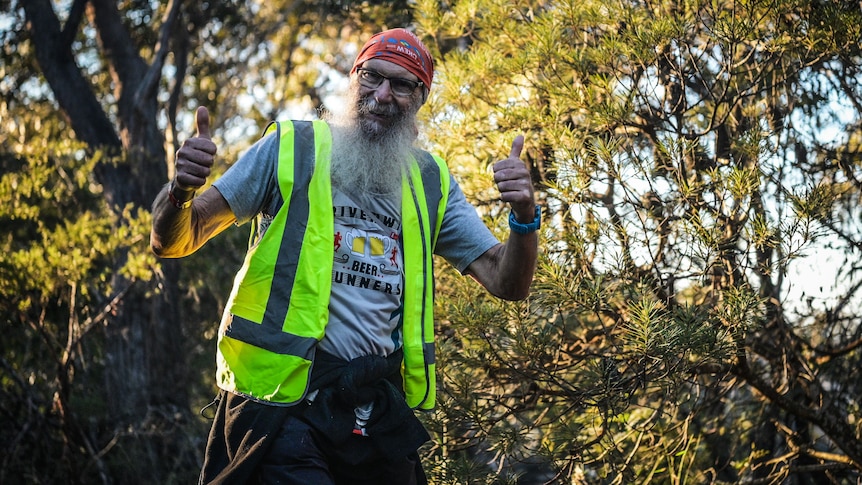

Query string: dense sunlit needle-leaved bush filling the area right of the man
[417,0,862,483]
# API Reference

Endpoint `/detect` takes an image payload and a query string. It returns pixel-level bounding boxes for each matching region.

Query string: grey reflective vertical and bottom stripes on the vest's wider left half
[226,121,317,358]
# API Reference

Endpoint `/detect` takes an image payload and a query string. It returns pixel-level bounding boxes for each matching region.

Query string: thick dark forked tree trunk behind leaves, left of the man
[22,0,190,476]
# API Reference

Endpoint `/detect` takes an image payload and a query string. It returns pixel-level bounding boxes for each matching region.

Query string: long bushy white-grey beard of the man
[329,91,416,199]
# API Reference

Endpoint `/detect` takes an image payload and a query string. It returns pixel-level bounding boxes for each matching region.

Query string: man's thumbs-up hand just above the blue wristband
[494,135,536,223]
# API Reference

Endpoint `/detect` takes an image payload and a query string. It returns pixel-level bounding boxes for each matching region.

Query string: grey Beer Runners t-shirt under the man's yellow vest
[213,129,499,360]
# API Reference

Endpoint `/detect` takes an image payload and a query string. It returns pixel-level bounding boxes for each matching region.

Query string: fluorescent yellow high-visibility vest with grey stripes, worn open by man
[216,121,450,409]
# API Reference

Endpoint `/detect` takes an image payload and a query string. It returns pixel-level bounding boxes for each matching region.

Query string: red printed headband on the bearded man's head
[350,29,434,89]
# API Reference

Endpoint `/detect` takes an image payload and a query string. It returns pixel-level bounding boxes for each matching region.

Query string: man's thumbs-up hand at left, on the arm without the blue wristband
[174,106,217,190]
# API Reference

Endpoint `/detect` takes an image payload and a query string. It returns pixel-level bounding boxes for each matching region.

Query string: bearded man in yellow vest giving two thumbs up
[151,29,539,484]
